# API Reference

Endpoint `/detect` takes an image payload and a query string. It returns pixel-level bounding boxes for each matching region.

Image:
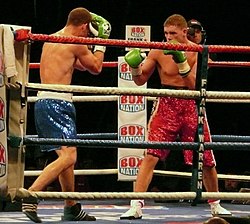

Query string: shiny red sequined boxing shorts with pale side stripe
[147,97,216,167]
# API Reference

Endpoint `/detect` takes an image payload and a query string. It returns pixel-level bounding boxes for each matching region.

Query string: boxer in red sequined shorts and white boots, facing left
[120,14,231,219]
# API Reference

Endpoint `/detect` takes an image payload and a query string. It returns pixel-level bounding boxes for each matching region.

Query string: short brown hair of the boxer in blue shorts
[66,7,92,26]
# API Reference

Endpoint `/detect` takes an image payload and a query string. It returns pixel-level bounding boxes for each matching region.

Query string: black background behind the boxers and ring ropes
[0,0,250,191]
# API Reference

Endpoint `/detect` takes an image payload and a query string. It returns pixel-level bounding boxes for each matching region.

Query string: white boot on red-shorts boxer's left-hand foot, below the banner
[120,200,144,220]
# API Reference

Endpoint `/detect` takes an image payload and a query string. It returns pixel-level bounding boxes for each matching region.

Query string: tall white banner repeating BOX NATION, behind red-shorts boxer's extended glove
[118,57,147,181]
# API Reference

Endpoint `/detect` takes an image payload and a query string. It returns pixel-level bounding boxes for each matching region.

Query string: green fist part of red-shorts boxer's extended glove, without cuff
[124,48,146,68]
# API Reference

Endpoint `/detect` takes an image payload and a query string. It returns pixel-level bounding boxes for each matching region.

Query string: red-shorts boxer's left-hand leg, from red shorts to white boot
[120,99,178,219]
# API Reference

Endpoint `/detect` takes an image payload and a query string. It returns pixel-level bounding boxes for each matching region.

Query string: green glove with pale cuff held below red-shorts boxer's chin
[163,40,191,78]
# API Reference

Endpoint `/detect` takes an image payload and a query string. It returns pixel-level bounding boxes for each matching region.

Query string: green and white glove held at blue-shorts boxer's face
[89,13,111,39]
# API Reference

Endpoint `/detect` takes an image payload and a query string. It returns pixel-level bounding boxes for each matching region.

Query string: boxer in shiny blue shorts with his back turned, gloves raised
[22,7,111,223]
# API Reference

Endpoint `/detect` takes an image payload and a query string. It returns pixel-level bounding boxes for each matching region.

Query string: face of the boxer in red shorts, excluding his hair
[164,25,187,43]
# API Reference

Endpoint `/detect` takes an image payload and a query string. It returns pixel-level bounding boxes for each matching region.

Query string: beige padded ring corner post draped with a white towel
[0,24,31,202]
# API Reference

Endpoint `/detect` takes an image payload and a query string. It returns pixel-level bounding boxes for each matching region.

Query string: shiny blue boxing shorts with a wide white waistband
[34,91,77,152]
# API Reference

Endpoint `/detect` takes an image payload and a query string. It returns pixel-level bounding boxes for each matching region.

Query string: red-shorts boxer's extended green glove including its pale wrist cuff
[124,48,146,76]
